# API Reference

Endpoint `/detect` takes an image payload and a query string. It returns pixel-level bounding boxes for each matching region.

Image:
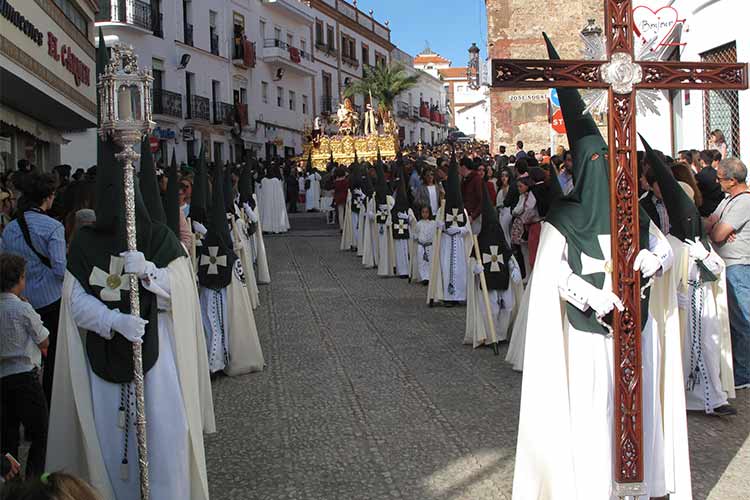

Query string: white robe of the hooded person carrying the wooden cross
[513,224,691,500]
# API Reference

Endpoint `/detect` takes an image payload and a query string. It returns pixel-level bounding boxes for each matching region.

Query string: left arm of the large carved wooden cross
[492,59,609,89]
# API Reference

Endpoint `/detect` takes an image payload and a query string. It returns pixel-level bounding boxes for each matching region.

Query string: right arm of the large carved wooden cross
[636,61,748,90]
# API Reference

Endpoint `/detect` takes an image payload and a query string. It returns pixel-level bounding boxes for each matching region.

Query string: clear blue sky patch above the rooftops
[357,0,487,66]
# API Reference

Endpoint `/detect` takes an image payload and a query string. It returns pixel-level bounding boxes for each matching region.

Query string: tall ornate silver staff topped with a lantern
[97,44,156,500]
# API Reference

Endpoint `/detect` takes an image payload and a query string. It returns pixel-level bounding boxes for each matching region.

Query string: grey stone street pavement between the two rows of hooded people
[206,214,750,500]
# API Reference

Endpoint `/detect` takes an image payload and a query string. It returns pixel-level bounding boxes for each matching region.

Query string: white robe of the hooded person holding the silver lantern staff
[47,258,216,500]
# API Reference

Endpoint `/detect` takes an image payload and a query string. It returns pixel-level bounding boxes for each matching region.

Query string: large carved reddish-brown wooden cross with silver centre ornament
[491,0,748,497]
